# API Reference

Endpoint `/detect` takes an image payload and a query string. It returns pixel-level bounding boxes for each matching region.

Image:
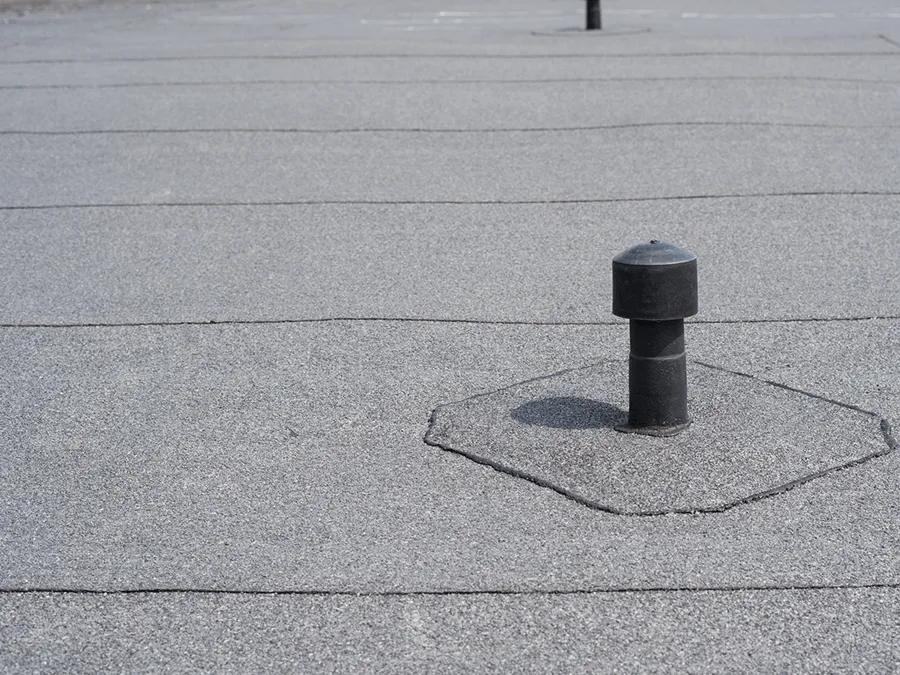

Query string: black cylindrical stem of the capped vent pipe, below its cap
[628,319,690,428]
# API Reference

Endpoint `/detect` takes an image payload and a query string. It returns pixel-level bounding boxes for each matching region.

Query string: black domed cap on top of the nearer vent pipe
[613,239,697,321]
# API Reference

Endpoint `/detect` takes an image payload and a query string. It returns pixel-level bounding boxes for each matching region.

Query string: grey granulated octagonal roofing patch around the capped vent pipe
[425,361,893,515]
